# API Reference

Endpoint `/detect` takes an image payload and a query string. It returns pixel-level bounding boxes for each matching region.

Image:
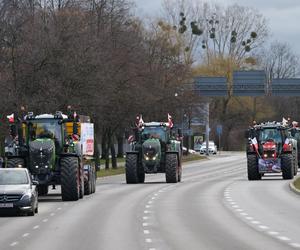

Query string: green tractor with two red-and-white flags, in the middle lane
[125,115,182,183]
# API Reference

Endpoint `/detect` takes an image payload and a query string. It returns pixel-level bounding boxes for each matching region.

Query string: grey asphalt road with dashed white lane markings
[0,153,300,250]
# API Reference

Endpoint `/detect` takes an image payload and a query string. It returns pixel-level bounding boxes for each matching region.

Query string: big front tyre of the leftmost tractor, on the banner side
[60,157,81,201]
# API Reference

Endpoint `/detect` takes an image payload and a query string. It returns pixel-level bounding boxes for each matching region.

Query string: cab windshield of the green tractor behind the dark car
[30,119,62,145]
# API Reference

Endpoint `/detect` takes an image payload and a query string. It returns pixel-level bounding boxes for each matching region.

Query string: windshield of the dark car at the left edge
[0,169,29,185]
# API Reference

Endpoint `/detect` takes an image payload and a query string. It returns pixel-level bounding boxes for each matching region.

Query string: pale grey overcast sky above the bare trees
[134,0,300,54]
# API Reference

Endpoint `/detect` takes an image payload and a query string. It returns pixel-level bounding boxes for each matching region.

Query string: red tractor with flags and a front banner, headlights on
[245,122,298,180]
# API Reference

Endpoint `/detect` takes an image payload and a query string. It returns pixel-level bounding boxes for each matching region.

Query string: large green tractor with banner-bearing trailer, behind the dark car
[5,111,96,201]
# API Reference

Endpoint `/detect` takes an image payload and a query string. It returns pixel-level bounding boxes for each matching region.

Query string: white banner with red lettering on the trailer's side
[80,123,94,156]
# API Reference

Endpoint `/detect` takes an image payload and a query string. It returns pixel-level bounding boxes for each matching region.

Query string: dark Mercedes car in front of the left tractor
[0,168,38,216]
